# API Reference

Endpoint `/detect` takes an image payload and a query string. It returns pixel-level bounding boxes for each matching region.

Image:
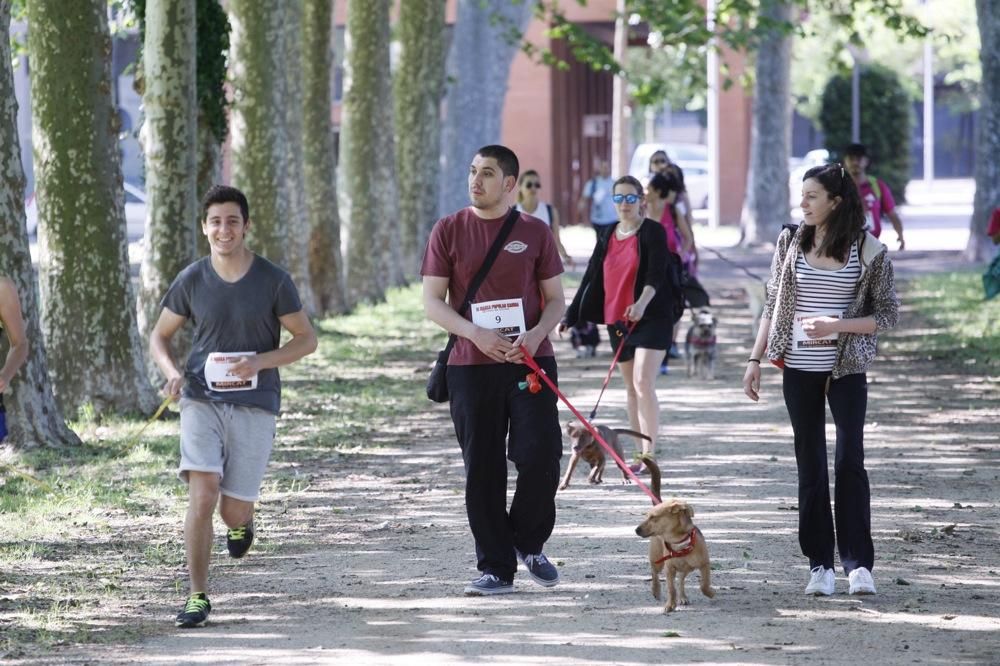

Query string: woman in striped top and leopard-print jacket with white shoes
[743,164,899,596]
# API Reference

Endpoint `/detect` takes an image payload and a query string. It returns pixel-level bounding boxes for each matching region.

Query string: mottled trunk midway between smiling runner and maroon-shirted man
[338,0,400,303]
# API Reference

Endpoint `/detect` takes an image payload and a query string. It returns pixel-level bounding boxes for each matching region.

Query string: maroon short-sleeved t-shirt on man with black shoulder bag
[420,208,563,365]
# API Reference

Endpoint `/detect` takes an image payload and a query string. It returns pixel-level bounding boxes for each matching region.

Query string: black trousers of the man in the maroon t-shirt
[448,357,562,580]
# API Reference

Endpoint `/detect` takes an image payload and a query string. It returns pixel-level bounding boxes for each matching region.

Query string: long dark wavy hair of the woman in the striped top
[800,164,865,261]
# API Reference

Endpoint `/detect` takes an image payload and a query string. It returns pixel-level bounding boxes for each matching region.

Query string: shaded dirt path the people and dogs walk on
[47,248,1000,665]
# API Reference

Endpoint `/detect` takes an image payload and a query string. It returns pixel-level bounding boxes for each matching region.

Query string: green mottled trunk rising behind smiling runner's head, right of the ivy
[228,0,293,266]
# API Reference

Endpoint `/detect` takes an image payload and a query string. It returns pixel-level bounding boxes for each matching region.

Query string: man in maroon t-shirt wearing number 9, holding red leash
[420,146,566,596]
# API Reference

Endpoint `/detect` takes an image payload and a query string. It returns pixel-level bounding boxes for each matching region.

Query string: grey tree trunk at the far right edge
[965,0,1000,261]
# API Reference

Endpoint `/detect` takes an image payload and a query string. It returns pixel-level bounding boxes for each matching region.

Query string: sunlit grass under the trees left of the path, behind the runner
[0,284,446,660]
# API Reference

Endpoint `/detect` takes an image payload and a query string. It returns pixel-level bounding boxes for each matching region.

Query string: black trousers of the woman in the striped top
[782,368,875,573]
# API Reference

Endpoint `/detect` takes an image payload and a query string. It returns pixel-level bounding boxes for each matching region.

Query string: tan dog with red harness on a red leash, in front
[635,490,715,613]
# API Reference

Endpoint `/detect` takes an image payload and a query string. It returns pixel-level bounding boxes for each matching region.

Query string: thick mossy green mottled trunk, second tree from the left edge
[28,0,158,415]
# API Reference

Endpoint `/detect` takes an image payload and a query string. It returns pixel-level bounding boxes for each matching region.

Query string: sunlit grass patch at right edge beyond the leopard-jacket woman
[903,271,1000,372]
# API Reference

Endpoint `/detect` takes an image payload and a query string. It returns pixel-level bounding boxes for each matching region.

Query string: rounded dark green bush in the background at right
[820,65,913,200]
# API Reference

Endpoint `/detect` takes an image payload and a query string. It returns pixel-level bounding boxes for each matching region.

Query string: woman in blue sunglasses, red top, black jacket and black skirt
[559,176,683,473]
